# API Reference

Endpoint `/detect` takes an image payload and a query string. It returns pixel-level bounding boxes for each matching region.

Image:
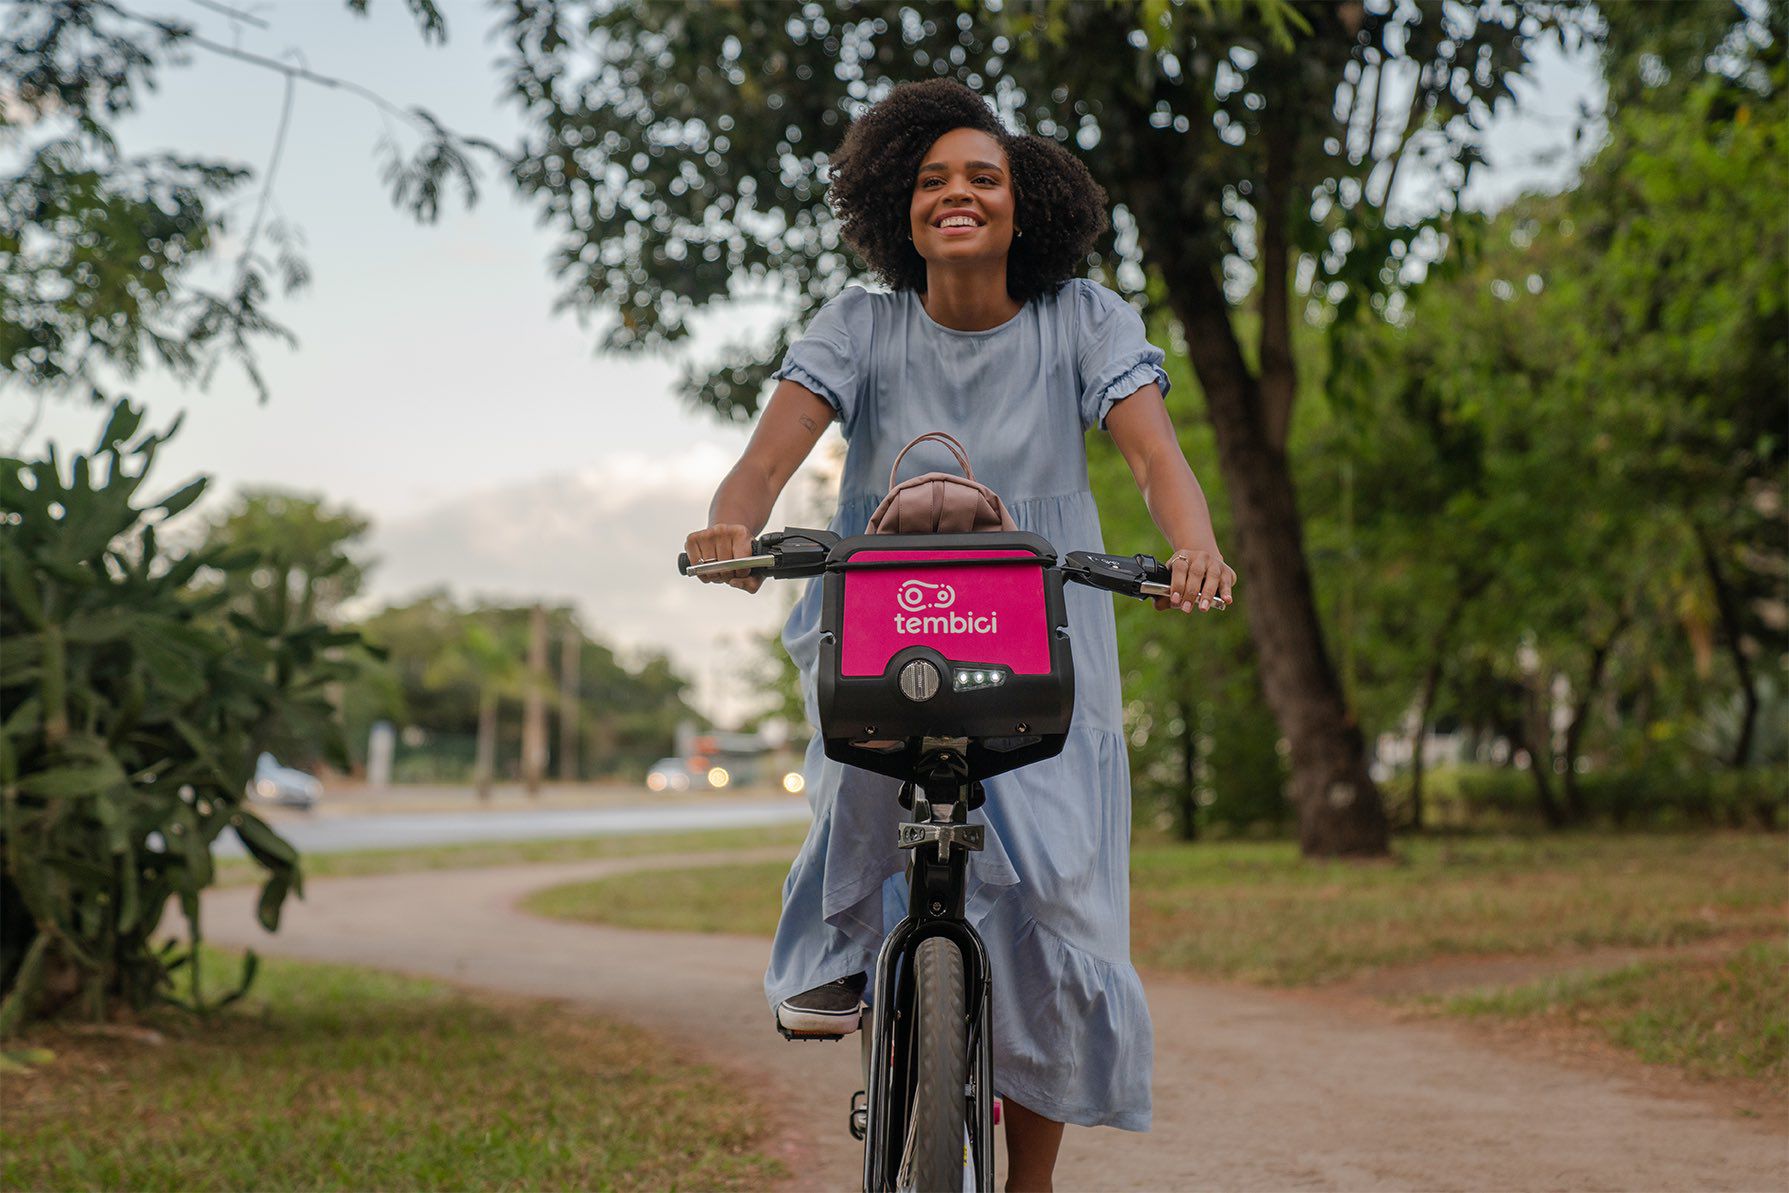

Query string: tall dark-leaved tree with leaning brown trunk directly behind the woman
[506,0,1576,855]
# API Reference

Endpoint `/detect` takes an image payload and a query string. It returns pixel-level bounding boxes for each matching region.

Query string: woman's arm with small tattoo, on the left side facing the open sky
[683,381,832,592]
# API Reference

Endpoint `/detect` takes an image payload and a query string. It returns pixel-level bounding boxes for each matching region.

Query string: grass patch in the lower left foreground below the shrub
[0,953,784,1189]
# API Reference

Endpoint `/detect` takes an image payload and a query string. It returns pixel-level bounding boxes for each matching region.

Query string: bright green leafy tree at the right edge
[1317,4,1789,825]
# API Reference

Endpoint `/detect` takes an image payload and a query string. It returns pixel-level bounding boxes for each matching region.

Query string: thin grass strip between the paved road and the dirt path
[218,821,807,885]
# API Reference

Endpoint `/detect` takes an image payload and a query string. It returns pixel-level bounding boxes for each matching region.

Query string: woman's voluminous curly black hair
[827,79,1106,302]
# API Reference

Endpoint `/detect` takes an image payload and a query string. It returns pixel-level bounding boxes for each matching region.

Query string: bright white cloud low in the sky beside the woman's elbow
[367,445,823,721]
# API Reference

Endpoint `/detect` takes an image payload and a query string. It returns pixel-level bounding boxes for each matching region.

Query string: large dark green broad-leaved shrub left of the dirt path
[0,402,358,1032]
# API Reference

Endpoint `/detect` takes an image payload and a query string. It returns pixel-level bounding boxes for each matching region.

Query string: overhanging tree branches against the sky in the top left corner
[0,0,508,420]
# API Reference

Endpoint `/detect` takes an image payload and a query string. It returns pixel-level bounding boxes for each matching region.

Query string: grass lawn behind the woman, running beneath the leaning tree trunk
[530,833,1789,986]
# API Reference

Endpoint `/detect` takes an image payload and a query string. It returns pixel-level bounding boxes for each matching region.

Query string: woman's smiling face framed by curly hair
[907,129,1016,273]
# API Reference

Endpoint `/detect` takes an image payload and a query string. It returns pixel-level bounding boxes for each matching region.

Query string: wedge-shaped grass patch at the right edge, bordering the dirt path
[1440,941,1789,1093]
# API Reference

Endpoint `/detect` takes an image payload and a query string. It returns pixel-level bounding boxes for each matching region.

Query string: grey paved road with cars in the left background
[216,798,809,857]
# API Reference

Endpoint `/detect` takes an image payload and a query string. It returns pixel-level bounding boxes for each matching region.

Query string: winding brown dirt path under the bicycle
[206,848,1789,1189]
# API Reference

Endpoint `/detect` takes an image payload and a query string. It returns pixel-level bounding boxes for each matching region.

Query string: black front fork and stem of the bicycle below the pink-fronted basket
[864,769,995,1193]
